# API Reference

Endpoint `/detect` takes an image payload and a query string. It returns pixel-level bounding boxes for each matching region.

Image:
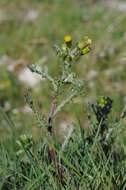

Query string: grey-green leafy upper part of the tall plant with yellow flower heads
[26,35,91,134]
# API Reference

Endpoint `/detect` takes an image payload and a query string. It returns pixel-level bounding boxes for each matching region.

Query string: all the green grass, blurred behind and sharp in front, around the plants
[0,0,126,190]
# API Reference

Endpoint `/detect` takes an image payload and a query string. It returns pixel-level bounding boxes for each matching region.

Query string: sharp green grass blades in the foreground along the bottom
[0,111,126,190]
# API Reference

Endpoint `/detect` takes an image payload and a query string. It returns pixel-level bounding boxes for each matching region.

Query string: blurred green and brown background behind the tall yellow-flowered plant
[0,0,126,141]
